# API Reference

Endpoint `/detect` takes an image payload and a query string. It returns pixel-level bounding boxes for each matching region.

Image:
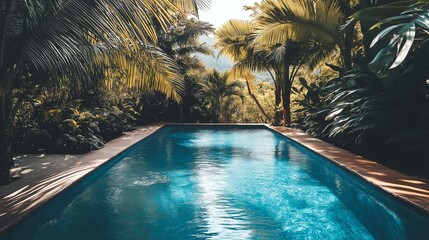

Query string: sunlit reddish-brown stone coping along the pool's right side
[268,126,429,214]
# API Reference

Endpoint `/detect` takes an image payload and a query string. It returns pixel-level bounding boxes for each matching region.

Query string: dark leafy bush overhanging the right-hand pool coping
[299,66,429,171]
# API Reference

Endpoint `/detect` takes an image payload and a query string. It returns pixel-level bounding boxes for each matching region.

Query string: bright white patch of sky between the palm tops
[199,0,260,28]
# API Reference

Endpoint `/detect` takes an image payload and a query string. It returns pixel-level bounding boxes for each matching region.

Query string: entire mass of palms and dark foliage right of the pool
[216,0,429,174]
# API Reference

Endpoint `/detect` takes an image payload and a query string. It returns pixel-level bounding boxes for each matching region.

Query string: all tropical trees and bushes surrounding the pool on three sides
[0,0,429,182]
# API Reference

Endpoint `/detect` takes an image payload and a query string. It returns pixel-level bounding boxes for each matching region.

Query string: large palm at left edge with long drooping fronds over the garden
[0,0,209,182]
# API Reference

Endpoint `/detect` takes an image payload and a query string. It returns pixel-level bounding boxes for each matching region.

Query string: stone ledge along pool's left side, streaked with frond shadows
[0,124,165,234]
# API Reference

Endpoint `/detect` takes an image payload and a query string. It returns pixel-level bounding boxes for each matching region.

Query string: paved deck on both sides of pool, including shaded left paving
[0,124,429,232]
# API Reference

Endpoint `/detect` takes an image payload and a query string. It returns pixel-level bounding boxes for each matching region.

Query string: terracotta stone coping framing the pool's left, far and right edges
[0,123,429,234]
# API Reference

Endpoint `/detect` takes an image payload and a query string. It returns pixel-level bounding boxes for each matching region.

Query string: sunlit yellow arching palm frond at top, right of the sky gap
[255,0,344,45]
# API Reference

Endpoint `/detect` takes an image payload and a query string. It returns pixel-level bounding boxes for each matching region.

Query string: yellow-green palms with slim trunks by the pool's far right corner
[216,1,343,125]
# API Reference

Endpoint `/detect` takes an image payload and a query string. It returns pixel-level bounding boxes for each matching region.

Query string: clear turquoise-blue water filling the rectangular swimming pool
[0,126,429,239]
